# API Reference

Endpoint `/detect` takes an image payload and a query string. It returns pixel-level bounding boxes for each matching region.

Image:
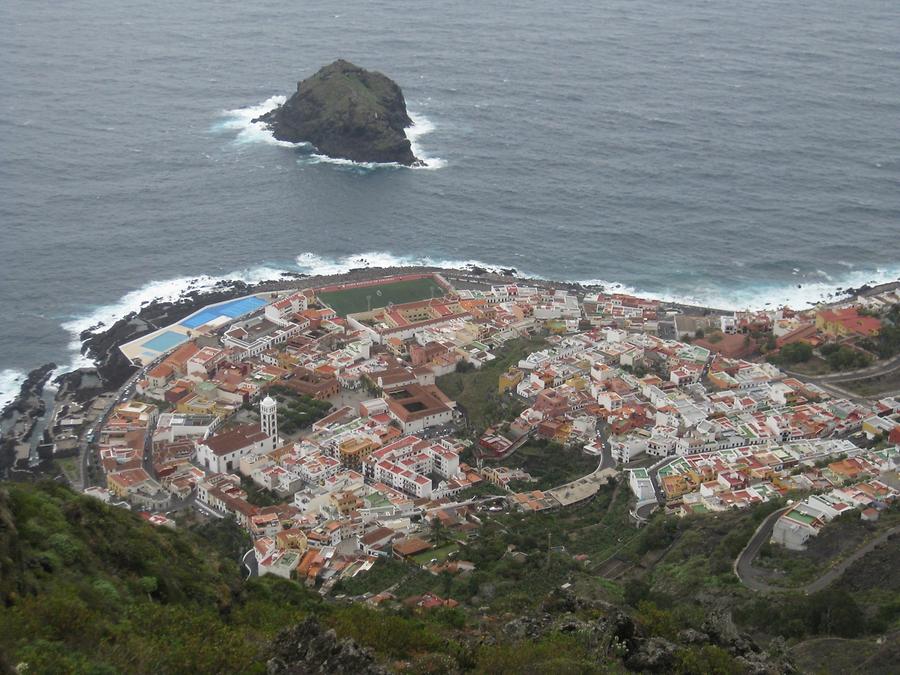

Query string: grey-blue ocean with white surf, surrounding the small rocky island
[0,0,900,401]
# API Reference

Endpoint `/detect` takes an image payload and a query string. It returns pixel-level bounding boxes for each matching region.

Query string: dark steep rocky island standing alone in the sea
[253,59,422,166]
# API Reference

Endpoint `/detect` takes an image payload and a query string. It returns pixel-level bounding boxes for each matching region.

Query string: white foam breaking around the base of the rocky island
[213,96,447,171]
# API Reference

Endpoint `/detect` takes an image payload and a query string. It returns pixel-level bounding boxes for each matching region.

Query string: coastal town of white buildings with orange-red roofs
[56,273,900,606]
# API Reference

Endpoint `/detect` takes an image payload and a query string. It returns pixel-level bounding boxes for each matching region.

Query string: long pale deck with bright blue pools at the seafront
[119,293,271,365]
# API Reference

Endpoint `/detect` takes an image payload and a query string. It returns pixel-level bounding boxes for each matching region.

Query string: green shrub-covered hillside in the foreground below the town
[0,483,898,673]
